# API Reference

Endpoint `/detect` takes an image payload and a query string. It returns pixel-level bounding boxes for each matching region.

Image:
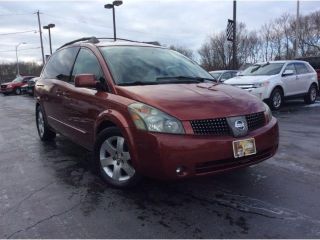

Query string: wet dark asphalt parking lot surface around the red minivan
[0,95,320,238]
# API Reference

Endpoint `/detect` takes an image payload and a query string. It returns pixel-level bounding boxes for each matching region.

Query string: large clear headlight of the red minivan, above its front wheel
[128,103,184,134]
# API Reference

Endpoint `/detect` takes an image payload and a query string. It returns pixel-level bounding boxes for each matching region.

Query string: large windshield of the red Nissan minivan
[100,46,214,85]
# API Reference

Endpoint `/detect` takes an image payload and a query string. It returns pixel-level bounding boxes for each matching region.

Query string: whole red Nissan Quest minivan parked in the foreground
[35,38,279,187]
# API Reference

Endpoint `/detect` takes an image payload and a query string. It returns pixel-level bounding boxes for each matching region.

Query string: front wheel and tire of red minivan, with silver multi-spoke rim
[94,127,141,188]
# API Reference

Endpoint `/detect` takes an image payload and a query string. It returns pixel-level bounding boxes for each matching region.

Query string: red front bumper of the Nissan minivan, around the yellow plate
[130,118,279,179]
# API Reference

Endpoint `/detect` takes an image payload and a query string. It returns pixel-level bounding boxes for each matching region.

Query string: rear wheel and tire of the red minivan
[36,106,56,142]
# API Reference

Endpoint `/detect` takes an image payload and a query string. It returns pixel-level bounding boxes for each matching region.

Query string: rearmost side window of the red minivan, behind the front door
[42,47,79,82]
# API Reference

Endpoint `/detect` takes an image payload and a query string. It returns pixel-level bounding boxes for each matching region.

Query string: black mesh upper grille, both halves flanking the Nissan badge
[190,112,265,136]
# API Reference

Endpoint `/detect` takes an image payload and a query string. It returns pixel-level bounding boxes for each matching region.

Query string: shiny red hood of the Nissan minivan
[117,83,265,120]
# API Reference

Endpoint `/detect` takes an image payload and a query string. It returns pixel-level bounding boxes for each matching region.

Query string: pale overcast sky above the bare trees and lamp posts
[0,0,320,62]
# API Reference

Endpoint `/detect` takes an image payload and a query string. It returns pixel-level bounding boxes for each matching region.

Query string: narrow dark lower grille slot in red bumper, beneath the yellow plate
[195,148,274,174]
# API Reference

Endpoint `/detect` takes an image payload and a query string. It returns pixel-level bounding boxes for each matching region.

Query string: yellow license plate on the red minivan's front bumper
[232,138,257,158]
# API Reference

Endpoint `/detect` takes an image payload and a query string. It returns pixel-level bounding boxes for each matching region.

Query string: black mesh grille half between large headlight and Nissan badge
[191,118,231,136]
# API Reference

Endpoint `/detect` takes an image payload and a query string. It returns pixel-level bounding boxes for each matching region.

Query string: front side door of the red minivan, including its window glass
[63,48,108,147]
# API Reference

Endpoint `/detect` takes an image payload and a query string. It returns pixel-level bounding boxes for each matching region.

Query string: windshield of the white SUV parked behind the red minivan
[241,63,284,76]
